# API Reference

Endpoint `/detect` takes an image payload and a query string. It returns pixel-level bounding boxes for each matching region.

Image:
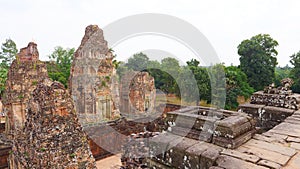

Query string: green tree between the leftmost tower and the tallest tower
[47,46,75,87]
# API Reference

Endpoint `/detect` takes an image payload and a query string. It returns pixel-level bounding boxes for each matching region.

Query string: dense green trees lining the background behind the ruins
[0,34,300,110]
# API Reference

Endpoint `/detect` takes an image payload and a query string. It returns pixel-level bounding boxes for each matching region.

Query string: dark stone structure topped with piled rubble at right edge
[238,78,300,131]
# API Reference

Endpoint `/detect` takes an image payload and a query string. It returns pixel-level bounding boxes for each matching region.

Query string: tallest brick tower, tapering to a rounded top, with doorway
[69,25,119,124]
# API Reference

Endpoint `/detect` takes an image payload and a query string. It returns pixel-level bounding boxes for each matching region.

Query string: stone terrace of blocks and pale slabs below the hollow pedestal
[123,108,300,169]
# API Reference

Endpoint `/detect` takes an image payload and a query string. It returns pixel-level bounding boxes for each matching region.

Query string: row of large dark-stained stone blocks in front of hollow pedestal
[121,132,224,169]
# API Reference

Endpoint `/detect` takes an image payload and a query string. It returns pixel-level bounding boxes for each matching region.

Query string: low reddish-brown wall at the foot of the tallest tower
[85,117,167,159]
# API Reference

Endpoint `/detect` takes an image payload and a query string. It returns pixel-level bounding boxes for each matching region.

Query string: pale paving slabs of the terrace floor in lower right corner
[217,111,300,169]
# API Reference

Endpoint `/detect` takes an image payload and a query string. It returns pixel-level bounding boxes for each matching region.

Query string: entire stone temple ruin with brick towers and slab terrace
[0,25,300,169]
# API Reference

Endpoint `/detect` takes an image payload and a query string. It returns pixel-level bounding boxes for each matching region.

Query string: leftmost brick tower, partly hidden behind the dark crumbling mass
[2,42,48,138]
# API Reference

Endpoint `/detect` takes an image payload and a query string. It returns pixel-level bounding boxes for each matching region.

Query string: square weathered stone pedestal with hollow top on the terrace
[166,107,255,149]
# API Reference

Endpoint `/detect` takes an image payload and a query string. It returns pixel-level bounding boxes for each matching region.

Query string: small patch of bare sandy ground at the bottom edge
[96,154,122,169]
